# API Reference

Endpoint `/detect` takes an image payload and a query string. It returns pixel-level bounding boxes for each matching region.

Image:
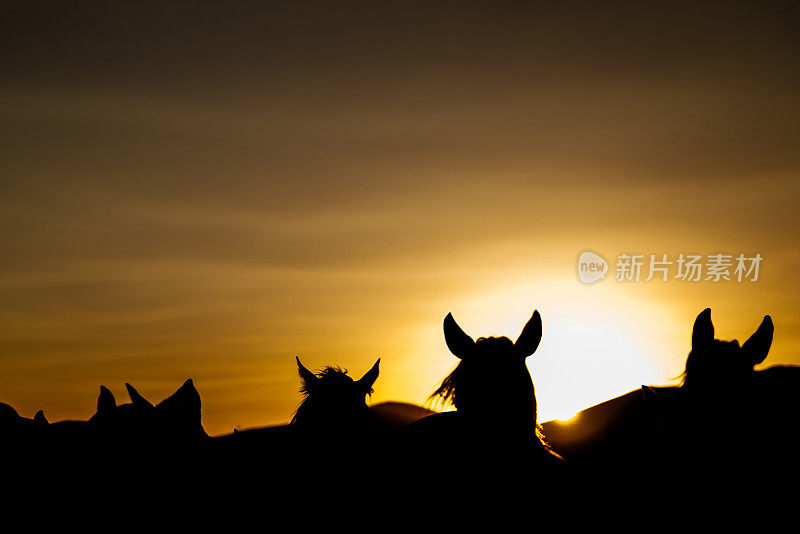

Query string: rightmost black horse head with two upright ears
[683,308,774,393]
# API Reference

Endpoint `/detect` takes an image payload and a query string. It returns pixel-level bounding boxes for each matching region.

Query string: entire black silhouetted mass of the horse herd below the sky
[0,309,800,508]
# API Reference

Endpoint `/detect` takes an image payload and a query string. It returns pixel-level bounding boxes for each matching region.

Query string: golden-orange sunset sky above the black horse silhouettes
[0,2,800,434]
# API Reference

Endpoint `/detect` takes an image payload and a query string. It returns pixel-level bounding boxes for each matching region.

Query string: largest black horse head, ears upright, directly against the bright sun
[431,311,542,433]
